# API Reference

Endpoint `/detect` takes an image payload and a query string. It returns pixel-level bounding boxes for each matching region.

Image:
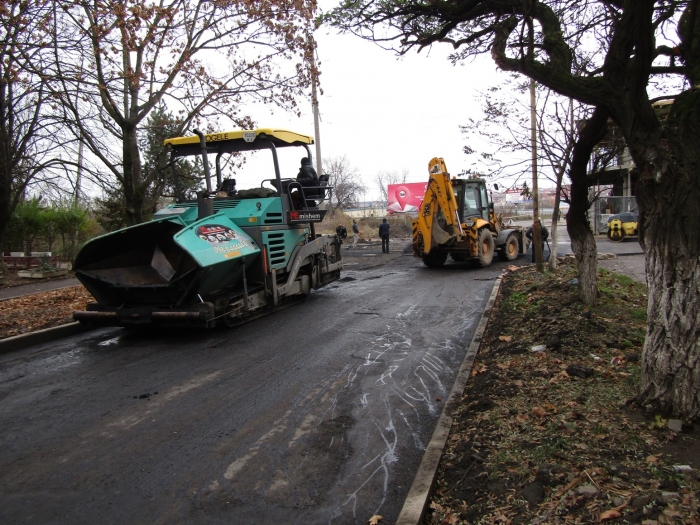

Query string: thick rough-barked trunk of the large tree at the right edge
[637,89,700,420]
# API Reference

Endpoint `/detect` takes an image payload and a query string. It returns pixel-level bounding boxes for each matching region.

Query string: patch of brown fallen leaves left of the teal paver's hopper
[0,286,94,339]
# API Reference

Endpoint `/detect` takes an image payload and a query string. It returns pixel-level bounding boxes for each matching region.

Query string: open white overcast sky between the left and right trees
[237,12,516,200]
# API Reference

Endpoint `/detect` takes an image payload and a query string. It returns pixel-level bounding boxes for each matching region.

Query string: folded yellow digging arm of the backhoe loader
[413,157,464,257]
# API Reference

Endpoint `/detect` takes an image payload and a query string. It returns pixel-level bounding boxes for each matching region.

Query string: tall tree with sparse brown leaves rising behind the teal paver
[41,0,315,224]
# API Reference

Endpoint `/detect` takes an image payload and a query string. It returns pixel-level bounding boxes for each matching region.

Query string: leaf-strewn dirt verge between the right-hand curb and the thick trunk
[425,264,700,525]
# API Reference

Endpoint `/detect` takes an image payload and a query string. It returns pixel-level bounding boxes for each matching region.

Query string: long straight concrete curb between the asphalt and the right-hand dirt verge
[396,277,502,525]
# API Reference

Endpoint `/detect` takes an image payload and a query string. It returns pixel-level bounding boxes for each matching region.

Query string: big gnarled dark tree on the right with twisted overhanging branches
[326,0,700,419]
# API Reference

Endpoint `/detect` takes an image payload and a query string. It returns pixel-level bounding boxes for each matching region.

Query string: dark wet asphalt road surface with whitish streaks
[0,242,527,524]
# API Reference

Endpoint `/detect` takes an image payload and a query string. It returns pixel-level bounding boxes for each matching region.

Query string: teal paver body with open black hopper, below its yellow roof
[74,130,342,327]
